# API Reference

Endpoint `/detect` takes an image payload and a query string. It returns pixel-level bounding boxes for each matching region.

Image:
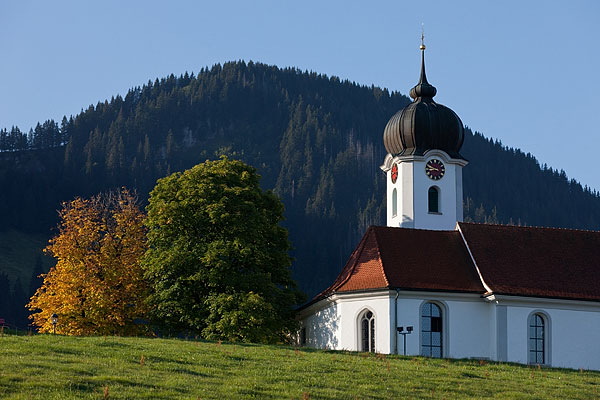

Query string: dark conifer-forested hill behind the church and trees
[0,62,600,304]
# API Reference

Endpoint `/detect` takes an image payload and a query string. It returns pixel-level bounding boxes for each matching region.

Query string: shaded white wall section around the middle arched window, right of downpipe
[392,292,492,358]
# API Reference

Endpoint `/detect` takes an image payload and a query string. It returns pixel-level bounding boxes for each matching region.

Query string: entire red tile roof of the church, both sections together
[313,222,600,301]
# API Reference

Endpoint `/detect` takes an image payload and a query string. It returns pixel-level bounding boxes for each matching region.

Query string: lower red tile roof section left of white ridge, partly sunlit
[317,226,485,297]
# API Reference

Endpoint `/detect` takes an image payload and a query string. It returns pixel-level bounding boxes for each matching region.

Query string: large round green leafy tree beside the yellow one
[143,157,303,342]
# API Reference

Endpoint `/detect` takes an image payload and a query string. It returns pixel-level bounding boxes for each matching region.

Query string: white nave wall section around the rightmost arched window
[499,298,600,370]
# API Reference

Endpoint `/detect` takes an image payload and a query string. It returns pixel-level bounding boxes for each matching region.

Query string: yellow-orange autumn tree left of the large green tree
[27,188,149,335]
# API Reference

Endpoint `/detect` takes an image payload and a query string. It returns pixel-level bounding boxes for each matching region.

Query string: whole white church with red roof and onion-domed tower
[298,44,600,370]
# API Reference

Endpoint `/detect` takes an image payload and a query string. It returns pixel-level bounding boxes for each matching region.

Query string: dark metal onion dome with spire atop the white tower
[383,44,464,159]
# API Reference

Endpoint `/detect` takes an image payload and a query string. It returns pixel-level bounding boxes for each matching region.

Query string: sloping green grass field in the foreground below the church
[0,335,600,400]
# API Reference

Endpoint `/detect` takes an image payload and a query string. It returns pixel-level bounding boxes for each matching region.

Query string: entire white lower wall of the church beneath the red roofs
[300,290,600,370]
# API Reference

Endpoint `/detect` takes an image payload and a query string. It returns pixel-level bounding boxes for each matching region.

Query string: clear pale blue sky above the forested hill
[0,0,600,189]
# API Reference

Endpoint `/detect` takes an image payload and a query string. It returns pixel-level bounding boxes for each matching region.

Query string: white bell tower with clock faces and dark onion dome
[381,37,468,230]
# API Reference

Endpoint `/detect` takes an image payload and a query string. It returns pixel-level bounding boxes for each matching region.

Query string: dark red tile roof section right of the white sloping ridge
[459,222,600,301]
